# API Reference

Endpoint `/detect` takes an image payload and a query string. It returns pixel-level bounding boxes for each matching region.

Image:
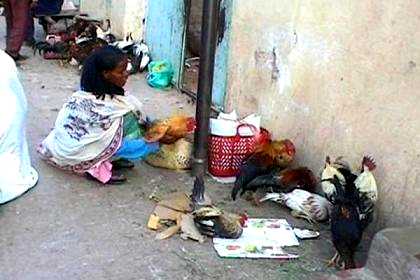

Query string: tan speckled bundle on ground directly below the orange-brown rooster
[146,139,193,170]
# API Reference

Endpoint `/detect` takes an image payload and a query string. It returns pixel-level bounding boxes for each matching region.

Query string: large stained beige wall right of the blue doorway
[226,0,420,227]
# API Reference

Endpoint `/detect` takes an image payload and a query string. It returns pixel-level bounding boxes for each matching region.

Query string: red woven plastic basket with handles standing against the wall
[209,124,270,177]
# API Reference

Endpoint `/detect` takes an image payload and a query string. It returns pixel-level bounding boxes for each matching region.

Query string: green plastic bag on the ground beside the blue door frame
[147,60,174,89]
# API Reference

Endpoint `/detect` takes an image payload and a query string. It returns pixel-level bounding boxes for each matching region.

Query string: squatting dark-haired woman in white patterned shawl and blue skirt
[38,46,159,184]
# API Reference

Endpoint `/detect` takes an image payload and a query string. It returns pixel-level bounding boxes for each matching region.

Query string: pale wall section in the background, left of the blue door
[80,0,147,39]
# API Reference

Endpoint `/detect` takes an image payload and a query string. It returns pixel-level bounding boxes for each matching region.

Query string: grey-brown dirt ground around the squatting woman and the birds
[0,18,370,280]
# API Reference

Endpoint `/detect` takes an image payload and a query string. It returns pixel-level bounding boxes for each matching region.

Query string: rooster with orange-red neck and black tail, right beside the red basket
[231,139,296,200]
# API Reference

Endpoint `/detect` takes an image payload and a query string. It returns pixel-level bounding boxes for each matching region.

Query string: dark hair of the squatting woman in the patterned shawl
[80,46,125,99]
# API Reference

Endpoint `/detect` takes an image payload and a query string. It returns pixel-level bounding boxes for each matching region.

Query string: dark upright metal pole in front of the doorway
[192,0,220,205]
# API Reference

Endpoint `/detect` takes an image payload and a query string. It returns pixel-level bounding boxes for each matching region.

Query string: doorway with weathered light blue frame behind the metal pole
[146,0,233,110]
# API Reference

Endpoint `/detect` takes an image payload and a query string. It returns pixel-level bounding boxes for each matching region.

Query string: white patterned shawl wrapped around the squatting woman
[38,91,141,173]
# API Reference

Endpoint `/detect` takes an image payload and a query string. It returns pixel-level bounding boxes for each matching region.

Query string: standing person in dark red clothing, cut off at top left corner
[5,0,37,61]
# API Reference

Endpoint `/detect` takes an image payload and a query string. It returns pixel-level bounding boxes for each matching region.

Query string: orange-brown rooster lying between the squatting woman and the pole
[144,116,196,144]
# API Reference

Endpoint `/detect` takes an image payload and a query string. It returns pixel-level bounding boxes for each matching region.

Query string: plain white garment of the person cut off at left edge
[0,50,38,204]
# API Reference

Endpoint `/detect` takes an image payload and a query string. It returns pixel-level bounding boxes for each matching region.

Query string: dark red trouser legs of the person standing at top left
[6,0,30,59]
